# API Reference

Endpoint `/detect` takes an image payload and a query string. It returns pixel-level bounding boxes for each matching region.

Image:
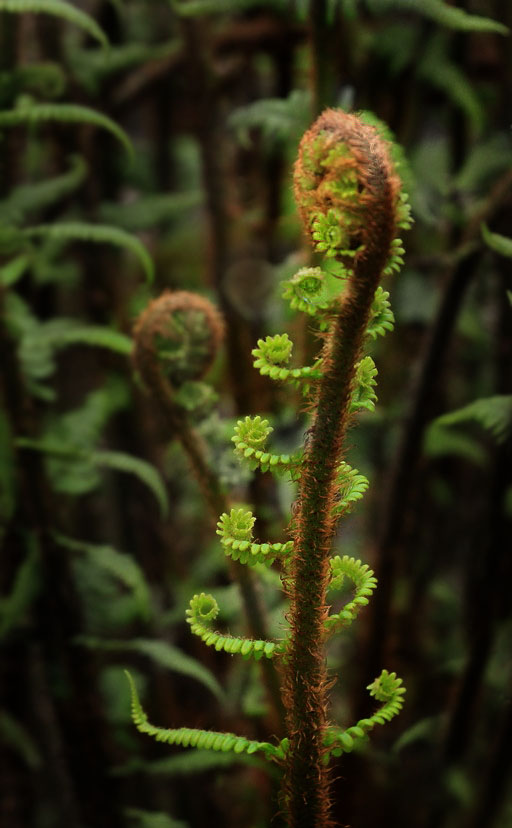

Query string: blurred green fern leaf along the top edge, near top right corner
[366,0,508,35]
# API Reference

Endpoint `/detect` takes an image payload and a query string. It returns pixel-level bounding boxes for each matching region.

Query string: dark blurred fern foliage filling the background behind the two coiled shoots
[0,0,512,828]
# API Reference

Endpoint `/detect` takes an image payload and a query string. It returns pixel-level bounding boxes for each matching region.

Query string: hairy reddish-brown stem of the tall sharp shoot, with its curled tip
[284,110,397,828]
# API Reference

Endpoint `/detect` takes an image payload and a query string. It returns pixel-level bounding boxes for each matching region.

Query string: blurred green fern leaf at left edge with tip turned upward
[0,155,87,224]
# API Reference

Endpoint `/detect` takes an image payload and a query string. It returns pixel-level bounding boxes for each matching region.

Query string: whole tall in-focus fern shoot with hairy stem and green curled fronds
[126,110,410,828]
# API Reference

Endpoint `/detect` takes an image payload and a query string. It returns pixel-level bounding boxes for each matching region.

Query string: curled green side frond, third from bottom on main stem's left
[217,507,293,566]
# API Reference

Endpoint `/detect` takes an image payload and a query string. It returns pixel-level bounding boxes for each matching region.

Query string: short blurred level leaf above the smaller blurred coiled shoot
[100,191,203,231]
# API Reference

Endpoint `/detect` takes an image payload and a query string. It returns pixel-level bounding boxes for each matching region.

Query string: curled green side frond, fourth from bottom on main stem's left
[231,414,302,476]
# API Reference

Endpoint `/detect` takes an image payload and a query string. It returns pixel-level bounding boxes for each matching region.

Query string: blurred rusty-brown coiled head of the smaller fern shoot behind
[133,290,224,388]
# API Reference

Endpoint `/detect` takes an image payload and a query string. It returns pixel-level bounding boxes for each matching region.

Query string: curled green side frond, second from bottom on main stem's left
[186,592,284,661]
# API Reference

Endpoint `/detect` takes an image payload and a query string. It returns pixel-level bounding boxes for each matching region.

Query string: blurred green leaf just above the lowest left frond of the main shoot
[80,636,224,701]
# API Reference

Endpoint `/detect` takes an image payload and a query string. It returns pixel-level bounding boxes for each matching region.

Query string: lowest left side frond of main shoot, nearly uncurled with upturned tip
[125,670,277,759]
